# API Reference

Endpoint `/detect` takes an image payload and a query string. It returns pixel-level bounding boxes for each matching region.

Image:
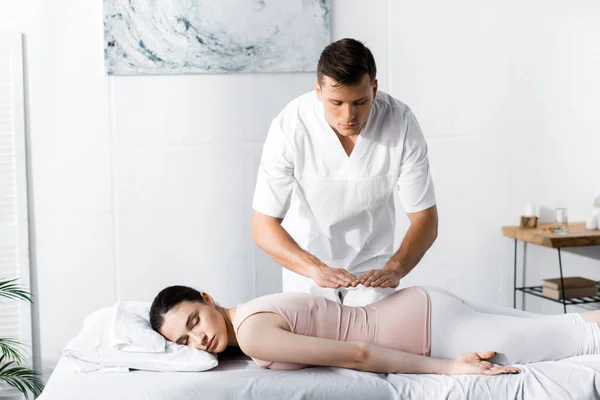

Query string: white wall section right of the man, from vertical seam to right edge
[389,0,600,312]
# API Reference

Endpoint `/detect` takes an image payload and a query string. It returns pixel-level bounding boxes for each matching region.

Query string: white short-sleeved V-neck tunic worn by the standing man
[253,91,435,273]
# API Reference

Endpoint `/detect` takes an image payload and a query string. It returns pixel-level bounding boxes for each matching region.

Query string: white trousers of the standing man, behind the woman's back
[282,268,395,307]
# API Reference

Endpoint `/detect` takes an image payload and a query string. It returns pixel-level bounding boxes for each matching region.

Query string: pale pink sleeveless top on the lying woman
[233,286,430,369]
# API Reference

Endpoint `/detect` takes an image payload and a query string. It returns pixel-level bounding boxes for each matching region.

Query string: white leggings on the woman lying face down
[424,287,600,364]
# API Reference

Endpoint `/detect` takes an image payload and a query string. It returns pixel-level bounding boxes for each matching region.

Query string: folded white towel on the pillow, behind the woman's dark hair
[110,301,167,353]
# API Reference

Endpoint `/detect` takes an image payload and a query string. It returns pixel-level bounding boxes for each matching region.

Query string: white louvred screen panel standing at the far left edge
[0,33,31,396]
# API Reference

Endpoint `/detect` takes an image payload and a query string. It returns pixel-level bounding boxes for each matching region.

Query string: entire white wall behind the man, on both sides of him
[0,0,600,378]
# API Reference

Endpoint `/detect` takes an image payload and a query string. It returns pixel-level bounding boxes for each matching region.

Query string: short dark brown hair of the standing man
[317,38,377,86]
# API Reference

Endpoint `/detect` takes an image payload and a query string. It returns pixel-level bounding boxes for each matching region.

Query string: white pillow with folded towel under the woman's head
[63,305,217,372]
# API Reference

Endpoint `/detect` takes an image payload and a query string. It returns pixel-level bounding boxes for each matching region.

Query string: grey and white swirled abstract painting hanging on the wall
[104,0,331,75]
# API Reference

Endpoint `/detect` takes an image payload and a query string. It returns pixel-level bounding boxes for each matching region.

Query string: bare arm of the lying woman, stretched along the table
[237,313,518,375]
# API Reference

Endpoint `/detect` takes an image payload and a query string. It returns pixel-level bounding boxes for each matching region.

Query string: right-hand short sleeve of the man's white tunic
[398,111,436,213]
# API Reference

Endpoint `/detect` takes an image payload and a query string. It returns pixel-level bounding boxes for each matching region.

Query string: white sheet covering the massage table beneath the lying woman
[39,355,600,400]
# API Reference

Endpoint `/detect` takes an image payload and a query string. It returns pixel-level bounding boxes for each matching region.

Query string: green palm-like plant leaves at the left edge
[0,279,44,400]
